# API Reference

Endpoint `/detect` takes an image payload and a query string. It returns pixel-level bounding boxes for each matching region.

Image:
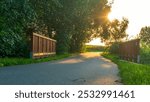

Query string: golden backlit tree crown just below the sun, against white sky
[100,18,129,45]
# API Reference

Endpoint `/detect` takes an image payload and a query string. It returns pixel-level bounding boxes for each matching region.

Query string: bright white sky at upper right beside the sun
[108,0,150,38]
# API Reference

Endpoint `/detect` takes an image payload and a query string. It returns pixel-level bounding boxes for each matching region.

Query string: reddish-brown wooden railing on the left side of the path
[30,33,56,58]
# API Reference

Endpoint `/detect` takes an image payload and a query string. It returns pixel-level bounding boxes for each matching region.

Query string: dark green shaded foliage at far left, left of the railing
[0,0,35,57]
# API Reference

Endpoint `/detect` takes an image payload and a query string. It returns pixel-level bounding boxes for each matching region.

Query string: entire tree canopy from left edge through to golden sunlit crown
[0,0,128,57]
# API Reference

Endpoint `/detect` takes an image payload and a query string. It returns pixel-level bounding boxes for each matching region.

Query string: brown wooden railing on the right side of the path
[119,39,140,63]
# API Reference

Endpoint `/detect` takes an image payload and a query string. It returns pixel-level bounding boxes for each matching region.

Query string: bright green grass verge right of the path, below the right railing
[102,53,150,85]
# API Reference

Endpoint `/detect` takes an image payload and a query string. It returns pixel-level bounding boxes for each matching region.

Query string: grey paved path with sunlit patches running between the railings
[0,52,120,85]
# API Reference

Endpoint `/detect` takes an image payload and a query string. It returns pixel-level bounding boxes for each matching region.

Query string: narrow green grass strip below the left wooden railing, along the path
[0,54,72,68]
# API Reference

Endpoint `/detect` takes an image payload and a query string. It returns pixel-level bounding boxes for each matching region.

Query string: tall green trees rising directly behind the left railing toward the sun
[31,0,110,53]
